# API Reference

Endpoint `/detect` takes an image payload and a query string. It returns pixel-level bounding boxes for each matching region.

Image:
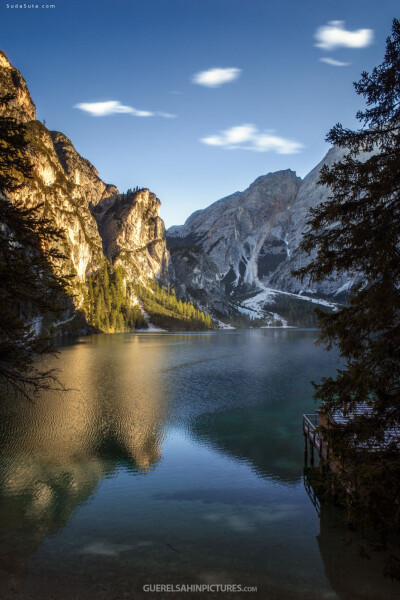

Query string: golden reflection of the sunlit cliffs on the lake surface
[0,336,165,578]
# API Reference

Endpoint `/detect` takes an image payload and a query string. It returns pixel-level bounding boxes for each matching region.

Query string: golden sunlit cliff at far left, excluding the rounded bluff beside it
[0,55,111,292]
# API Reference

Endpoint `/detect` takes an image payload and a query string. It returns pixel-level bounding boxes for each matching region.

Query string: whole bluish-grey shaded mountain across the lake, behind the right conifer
[167,148,357,305]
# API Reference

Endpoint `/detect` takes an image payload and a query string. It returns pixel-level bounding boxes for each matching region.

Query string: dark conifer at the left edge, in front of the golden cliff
[0,98,68,398]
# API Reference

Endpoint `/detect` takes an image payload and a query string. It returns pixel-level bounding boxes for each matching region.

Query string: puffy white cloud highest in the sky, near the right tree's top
[314,21,374,50]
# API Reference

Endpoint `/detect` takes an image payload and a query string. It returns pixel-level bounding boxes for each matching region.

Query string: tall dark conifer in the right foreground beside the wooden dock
[296,20,400,544]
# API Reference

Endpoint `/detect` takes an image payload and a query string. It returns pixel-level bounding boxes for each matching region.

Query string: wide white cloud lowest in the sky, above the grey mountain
[200,125,303,154]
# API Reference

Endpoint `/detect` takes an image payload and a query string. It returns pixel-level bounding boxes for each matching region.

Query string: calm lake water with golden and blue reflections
[0,329,400,600]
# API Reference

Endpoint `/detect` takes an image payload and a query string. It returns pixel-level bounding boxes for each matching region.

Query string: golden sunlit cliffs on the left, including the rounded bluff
[0,53,169,332]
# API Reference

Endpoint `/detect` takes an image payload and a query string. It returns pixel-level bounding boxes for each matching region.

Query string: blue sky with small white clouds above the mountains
[0,0,400,226]
